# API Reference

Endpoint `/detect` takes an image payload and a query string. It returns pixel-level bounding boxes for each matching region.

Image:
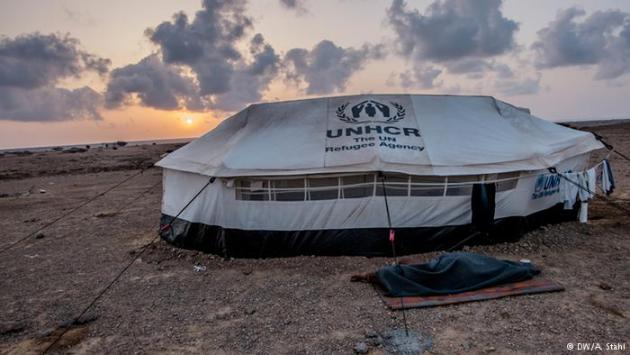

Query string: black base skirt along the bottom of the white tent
[161,204,577,258]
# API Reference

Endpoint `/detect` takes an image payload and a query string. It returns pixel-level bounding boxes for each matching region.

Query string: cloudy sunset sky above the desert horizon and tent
[0,0,630,149]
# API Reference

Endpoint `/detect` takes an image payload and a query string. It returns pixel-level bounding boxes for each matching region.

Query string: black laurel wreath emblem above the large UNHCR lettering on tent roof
[336,100,407,123]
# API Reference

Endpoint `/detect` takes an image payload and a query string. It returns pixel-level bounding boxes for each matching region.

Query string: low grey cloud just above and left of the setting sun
[105,54,204,110]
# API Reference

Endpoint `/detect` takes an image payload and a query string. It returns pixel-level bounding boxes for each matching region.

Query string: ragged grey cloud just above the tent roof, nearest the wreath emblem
[284,40,385,94]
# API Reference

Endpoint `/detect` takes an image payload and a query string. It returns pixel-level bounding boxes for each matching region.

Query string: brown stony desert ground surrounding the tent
[0,123,630,354]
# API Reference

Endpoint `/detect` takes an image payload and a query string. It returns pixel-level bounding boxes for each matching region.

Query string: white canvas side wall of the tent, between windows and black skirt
[162,154,588,231]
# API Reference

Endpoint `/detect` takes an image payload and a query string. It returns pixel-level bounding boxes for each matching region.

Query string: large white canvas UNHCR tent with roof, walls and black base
[157,95,603,256]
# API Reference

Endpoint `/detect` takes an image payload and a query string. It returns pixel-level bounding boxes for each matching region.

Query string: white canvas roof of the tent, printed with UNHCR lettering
[157,94,603,177]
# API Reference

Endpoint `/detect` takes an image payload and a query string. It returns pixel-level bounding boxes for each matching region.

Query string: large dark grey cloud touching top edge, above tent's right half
[387,0,518,62]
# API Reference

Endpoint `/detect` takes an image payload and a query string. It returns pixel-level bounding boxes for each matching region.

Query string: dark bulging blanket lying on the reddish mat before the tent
[376,252,540,297]
